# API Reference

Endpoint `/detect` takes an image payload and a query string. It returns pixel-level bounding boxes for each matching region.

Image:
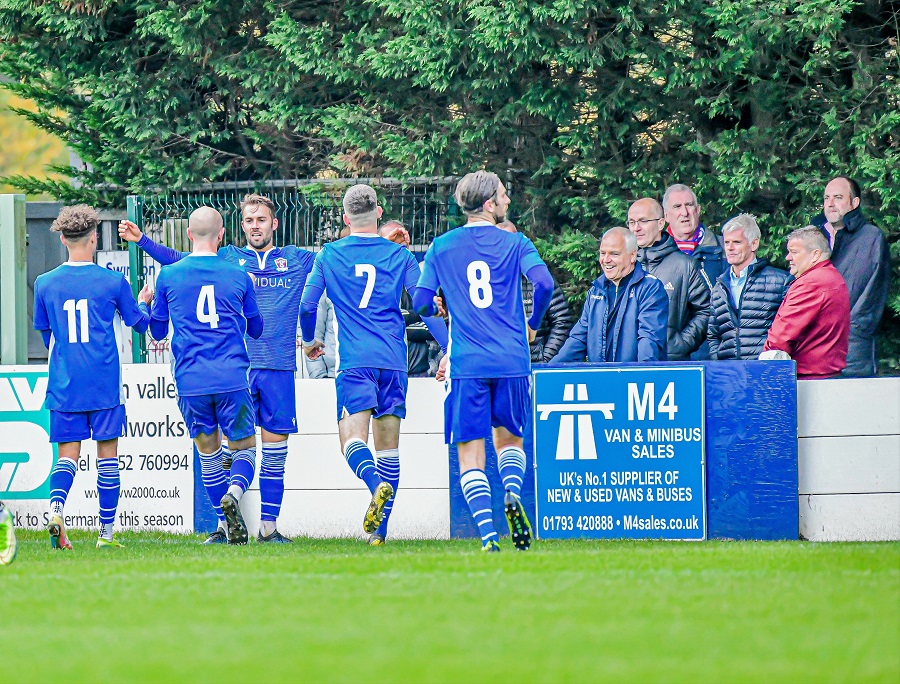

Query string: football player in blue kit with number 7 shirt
[300,185,446,545]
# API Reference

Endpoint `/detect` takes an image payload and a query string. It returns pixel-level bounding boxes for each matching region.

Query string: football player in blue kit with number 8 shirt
[413,171,553,552]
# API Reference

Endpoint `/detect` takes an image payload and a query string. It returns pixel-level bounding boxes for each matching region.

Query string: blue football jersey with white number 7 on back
[307,234,419,372]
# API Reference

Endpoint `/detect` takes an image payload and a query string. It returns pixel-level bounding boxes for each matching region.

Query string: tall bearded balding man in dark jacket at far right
[812,176,891,377]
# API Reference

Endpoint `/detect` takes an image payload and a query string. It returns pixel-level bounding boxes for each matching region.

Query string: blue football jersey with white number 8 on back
[419,222,544,378]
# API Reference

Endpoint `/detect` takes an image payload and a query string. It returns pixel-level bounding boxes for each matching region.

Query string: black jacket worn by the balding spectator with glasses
[638,233,711,361]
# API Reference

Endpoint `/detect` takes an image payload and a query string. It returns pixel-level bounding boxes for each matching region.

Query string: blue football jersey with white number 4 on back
[150,254,259,397]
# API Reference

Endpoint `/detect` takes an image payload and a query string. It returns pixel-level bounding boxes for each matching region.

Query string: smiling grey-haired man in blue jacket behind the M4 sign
[554,228,669,363]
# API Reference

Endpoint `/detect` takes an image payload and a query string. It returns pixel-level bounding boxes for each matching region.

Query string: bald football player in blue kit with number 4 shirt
[150,207,263,544]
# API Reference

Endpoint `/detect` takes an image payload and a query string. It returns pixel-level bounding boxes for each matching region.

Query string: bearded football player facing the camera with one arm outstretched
[119,195,315,544]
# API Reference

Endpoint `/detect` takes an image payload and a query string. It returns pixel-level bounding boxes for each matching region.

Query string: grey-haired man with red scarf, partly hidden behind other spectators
[663,183,728,282]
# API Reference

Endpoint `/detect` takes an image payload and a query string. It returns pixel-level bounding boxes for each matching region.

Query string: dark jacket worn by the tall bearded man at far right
[812,207,891,377]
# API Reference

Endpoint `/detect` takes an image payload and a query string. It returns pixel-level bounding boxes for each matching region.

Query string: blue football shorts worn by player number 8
[444,375,531,444]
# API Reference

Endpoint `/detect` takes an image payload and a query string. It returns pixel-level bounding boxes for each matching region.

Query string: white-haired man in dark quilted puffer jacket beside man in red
[708,214,793,361]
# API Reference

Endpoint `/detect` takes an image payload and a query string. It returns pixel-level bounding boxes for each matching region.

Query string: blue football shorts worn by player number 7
[334,368,408,421]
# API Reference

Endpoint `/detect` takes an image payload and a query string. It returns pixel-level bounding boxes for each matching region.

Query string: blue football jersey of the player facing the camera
[138,236,316,371]
